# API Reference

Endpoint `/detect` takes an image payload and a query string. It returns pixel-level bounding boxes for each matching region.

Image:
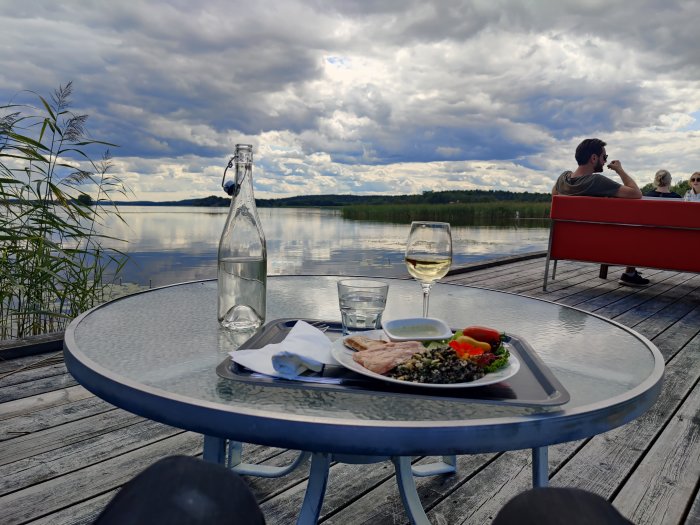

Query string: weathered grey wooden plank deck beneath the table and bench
[0,257,700,525]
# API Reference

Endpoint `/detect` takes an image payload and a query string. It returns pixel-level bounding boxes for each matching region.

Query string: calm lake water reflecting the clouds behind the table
[98,206,549,286]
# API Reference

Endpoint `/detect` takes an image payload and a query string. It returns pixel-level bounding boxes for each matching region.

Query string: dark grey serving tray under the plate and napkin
[216,319,570,406]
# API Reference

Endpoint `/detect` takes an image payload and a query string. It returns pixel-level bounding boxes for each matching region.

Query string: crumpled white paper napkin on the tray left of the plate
[229,321,338,378]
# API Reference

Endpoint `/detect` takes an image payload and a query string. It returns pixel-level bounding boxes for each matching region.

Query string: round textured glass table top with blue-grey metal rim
[64,276,664,455]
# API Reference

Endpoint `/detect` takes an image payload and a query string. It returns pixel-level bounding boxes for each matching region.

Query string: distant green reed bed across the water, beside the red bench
[341,201,550,226]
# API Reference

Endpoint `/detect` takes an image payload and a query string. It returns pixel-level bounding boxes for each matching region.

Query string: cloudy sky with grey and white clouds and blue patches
[0,0,700,201]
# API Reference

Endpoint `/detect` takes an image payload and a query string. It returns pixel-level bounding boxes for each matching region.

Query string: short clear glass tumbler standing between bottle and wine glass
[338,279,389,335]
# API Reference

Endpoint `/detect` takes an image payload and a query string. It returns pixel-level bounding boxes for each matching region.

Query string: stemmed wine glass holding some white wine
[405,221,452,317]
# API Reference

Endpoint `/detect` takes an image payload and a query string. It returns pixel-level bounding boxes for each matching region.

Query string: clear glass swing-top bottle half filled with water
[218,144,267,332]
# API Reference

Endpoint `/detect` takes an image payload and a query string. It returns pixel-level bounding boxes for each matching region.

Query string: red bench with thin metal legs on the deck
[542,195,700,291]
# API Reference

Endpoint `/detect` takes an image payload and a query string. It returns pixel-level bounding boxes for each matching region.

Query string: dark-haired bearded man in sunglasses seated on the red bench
[552,139,649,286]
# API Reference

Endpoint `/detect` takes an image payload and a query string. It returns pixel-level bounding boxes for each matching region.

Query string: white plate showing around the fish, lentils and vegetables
[331,330,520,388]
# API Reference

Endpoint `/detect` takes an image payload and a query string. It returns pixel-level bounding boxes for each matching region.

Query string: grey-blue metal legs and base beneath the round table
[203,436,549,525]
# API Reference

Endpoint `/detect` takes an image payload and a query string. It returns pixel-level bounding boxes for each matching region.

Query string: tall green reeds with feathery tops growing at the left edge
[0,83,127,339]
